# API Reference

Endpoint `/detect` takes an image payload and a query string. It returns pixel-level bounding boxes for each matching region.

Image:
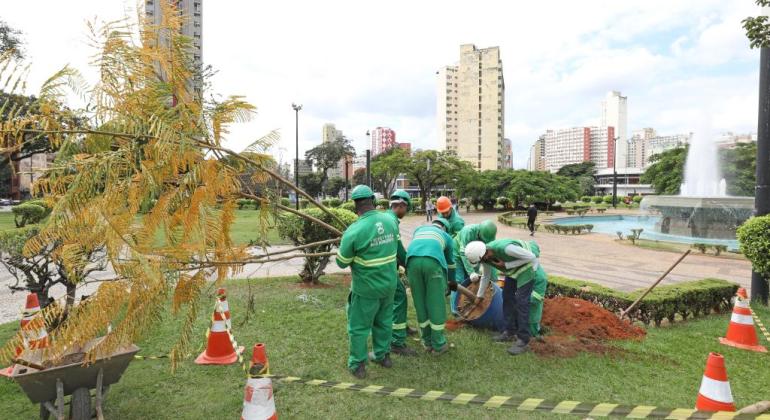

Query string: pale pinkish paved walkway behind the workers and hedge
[0,213,751,323]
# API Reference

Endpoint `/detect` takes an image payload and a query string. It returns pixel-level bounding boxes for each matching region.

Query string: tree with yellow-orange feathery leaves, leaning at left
[0,2,339,364]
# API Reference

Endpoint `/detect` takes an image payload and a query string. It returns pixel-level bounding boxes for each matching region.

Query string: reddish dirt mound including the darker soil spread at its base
[530,297,646,357]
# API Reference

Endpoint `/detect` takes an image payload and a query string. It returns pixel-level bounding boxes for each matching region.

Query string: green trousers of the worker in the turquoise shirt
[406,257,447,350]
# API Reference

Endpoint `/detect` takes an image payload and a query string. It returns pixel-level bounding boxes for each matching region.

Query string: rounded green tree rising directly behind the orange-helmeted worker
[406,150,473,208]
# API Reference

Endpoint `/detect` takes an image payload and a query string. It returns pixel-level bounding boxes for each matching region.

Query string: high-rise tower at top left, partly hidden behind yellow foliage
[144,0,203,97]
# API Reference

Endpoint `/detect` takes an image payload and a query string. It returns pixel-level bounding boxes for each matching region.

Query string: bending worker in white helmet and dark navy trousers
[465,239,540,355]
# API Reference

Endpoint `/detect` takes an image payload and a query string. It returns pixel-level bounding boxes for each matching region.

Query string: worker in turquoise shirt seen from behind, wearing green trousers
[406,219,457,355]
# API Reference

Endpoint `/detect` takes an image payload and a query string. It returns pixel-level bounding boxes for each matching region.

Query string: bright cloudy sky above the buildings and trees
[0,0,759,168]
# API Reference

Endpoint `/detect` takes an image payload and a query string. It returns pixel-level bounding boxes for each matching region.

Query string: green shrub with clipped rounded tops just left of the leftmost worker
[278,208,357,284]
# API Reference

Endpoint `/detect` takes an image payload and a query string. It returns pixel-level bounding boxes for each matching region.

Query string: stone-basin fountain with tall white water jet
[641,123,754,244]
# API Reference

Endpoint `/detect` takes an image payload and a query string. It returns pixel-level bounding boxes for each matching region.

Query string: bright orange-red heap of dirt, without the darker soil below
[541,297,646,340]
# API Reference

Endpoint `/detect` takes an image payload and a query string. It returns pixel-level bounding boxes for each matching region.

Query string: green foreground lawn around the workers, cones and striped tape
[0,276,770,419]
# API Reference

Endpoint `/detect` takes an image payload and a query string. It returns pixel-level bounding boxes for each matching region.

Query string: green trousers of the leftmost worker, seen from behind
[348,292,393,371]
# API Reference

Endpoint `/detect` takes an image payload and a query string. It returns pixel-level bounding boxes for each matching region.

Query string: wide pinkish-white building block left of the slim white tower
[535,126,615,172]
